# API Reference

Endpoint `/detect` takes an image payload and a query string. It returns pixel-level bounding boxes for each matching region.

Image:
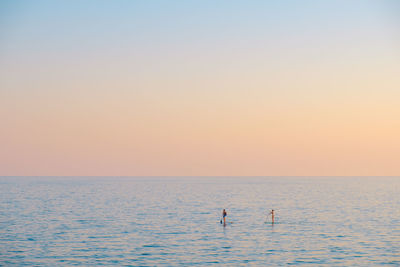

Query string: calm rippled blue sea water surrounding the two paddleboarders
[0,177,400,266]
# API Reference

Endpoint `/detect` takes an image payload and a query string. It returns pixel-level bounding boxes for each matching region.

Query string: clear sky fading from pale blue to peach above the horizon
[0,0,400,176]
